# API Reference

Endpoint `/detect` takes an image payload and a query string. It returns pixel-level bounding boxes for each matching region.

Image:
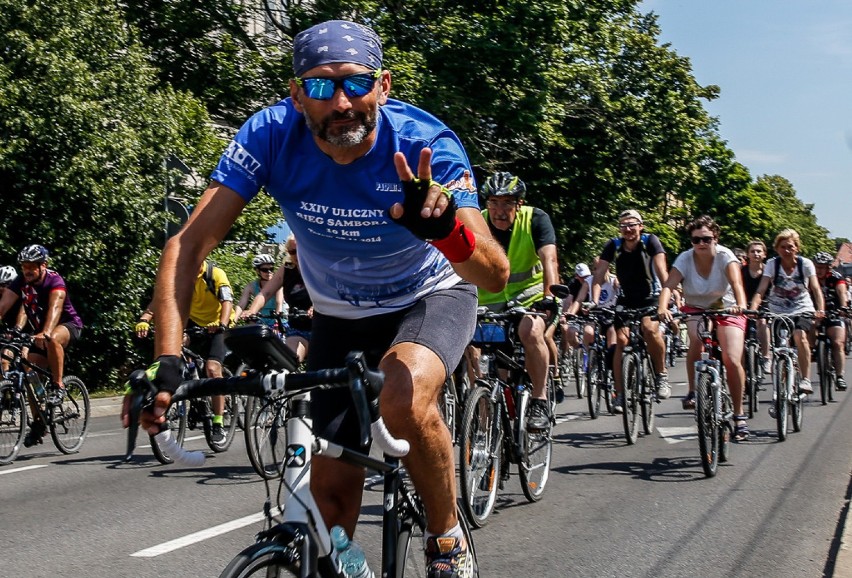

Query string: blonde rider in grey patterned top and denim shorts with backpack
[749,229,825,394]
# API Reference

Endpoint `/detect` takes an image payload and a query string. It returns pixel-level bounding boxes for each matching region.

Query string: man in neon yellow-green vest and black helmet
[473,172,559,429]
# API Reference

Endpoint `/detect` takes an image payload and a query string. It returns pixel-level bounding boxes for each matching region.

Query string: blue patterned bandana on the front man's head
[293,20,382,77]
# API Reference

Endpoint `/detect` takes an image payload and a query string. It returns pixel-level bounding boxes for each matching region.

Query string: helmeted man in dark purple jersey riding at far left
[0,245,83,447]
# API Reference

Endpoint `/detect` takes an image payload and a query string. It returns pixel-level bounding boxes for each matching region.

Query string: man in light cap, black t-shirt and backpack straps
[592,209,671,413]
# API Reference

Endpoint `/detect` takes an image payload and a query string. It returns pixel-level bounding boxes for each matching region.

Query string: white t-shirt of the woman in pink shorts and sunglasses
[672,245,740,309]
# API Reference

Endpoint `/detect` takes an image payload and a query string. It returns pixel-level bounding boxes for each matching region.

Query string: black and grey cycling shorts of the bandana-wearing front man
[307,282,477,449]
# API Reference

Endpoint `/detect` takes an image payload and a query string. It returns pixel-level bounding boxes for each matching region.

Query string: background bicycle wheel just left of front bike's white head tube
[243,397,289,480]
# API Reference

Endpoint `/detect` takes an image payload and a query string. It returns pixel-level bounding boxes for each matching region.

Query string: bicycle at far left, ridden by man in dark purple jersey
[0,329,90,464]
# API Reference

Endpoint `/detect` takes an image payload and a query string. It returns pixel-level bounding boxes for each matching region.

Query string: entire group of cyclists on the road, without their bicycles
[0,21,848,578]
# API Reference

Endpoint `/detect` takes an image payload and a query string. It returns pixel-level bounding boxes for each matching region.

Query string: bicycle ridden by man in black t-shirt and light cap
[615,306,660,445]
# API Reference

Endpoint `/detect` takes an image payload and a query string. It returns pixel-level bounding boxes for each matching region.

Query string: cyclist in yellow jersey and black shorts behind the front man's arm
[133,261,234,445]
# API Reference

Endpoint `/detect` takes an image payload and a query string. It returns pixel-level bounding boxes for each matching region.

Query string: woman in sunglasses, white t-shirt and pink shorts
[658,215,749,440]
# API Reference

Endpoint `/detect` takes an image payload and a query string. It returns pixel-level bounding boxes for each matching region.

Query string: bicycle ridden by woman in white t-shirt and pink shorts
[677,311,734,478]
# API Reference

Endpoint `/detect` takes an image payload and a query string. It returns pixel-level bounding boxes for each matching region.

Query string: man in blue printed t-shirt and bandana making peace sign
[134,21,509,578]
